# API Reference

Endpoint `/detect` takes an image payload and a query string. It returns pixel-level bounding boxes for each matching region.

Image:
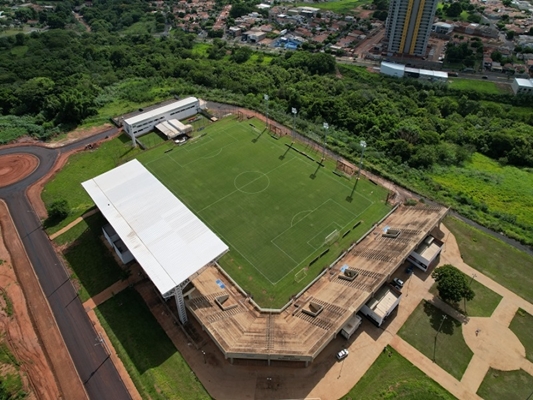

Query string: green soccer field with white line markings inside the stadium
[135,117,389,301]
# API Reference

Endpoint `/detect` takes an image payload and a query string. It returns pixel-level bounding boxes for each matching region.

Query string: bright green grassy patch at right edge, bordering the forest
[431,153,533,226]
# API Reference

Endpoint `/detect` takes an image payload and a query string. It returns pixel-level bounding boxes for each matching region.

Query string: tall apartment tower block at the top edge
[387,0,438,57]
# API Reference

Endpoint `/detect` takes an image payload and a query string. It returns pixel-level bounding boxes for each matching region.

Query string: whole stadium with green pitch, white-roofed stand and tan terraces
[83,104,447,366]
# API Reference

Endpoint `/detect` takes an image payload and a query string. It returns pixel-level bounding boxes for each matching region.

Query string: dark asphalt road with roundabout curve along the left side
[0,128,131,400]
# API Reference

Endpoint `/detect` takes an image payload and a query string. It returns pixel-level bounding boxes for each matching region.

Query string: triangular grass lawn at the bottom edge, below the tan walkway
[343,347,455,400]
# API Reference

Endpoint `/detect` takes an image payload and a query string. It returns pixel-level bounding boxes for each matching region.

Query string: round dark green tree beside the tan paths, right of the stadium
[431,264,476,311]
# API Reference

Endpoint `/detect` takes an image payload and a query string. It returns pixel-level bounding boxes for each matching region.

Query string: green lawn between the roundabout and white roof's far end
[41,135,141,234]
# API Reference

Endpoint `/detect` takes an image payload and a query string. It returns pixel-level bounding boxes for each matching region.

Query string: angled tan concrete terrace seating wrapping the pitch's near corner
[186,206,447,364]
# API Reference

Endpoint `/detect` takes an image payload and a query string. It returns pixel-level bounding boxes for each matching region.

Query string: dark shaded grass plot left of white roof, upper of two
[55,213,125,301]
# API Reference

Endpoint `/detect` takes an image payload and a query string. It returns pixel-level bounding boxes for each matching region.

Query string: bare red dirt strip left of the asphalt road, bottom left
[0,201,87,399]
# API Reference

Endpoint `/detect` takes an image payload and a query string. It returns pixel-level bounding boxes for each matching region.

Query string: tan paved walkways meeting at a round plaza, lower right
[390,225,533,399]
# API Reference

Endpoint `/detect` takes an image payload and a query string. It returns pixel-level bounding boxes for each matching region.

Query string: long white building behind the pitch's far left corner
[123,97,200,139]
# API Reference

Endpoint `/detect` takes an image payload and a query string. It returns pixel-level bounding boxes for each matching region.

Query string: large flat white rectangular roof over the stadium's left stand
[82,160,228,294]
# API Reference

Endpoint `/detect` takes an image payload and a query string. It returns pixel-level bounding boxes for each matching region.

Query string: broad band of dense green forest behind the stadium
[0,27,533,243]
